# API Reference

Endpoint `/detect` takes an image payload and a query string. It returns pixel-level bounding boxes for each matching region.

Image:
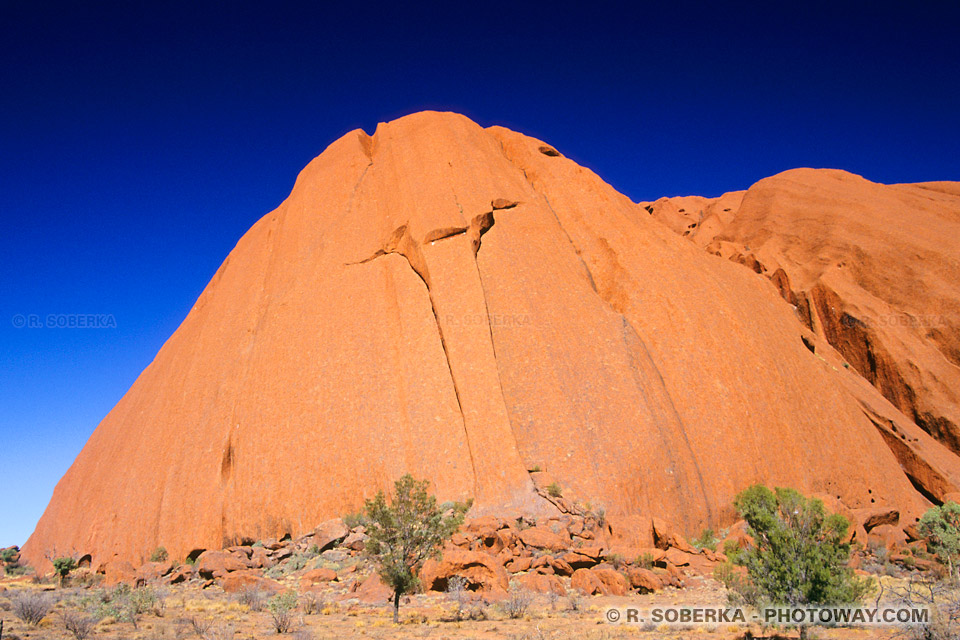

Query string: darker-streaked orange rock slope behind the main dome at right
[640,169,960,500]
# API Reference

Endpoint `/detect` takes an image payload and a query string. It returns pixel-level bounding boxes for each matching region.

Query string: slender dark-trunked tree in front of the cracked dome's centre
[364,474,471,623]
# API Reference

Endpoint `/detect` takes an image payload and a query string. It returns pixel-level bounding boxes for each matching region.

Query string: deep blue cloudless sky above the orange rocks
[0,0,960,546]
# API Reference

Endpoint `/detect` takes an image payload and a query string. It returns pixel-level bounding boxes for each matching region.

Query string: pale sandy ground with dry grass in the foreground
[0,577,916,640]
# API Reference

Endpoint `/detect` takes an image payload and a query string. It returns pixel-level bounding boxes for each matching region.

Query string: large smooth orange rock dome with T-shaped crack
[24,113,960,563]
